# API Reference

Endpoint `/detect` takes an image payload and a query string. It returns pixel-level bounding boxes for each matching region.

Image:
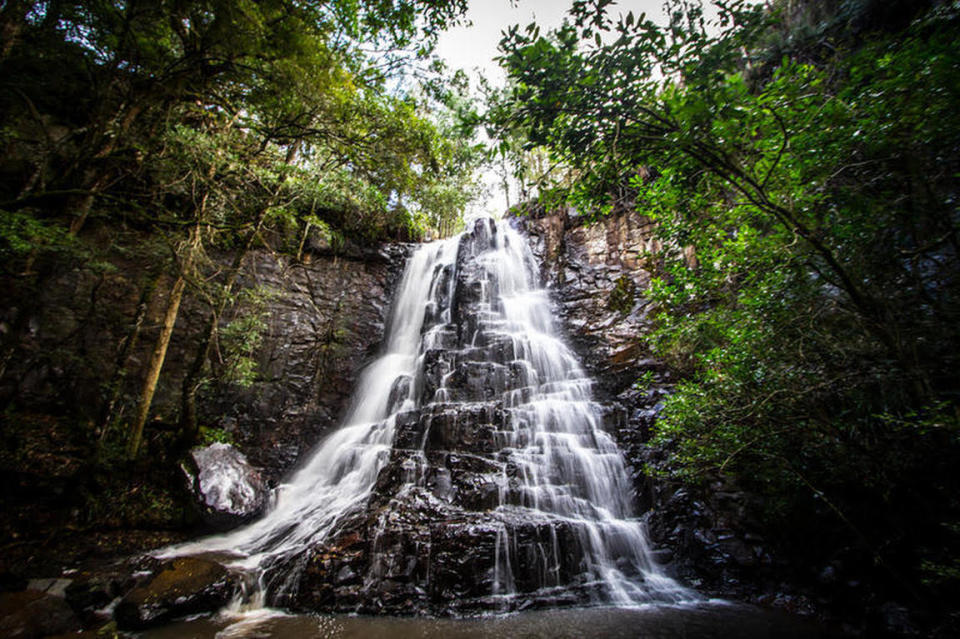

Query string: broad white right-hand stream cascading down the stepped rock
[446,221,692,605]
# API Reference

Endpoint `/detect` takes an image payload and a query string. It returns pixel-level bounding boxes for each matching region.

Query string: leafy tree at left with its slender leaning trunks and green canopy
[0,0,476,456]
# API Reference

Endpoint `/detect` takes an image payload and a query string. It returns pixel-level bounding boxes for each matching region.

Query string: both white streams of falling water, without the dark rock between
[160,221,692,605]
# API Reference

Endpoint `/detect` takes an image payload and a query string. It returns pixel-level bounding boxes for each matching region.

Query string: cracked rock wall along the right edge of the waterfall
[518,210,776,607]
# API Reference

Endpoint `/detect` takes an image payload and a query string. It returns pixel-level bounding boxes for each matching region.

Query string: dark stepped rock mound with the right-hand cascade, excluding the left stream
[278,221,684,614]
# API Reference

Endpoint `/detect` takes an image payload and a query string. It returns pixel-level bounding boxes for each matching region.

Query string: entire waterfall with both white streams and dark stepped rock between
[164,220,691,612]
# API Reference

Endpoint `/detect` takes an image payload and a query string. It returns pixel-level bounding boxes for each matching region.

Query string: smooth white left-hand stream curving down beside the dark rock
[157,239,456,570]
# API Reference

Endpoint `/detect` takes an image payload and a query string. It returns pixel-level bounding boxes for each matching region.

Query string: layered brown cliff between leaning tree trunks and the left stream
[191,245,409,479]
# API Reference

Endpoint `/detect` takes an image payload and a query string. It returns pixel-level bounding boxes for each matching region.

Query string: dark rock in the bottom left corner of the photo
[0,590,80,639]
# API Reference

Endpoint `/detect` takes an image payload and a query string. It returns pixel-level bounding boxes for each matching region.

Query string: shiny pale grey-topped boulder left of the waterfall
[181,443,269,530]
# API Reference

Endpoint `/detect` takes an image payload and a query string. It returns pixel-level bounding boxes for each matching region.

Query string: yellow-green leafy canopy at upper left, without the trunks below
[0,0,472,248]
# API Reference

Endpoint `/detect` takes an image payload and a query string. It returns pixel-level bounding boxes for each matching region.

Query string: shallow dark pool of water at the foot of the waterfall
[139,602,838,639]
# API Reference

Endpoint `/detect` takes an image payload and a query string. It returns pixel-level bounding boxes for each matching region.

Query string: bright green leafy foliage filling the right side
[493,1,960,620]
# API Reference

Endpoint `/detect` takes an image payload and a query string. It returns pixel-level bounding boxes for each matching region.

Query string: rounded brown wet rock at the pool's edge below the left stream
[114,557,238,630]
